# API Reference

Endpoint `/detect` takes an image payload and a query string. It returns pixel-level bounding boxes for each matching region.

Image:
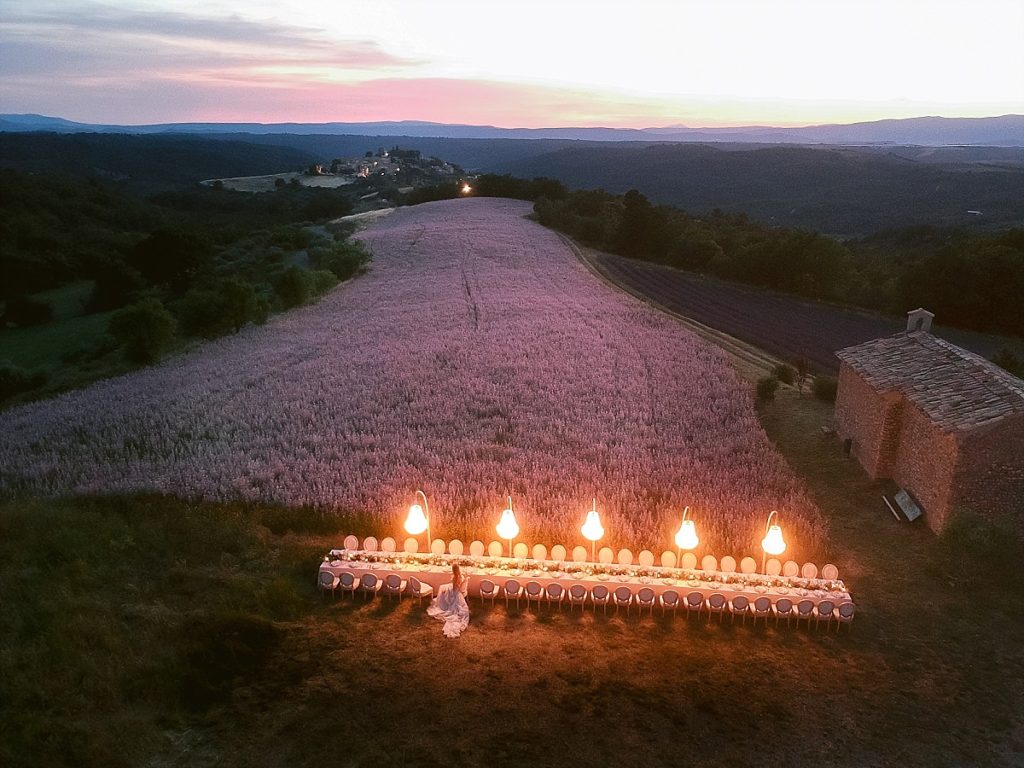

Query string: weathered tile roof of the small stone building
[836,332,1024,431]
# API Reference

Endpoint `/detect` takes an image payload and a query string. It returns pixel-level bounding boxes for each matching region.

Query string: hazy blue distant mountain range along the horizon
[0,115,1024,146]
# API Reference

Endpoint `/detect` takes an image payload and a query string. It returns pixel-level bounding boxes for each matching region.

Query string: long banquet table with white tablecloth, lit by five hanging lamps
[321,557,853,607]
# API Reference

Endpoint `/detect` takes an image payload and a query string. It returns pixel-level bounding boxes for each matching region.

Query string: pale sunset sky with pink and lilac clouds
[0,0,1024,127]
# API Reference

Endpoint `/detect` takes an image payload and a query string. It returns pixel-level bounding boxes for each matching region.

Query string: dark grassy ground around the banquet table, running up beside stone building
[0,391,1024,768]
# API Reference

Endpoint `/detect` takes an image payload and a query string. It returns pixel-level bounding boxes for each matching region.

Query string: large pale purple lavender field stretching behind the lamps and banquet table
[0,199,823,558]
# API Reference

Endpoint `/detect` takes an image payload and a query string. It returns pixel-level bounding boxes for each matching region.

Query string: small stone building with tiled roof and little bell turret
[836,309,1024,534]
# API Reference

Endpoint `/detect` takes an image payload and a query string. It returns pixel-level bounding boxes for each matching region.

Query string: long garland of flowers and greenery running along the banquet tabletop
[324,550,847,593]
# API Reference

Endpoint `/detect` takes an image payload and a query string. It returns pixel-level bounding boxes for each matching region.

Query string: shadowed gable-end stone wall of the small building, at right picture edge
[952,414,1024,537]
